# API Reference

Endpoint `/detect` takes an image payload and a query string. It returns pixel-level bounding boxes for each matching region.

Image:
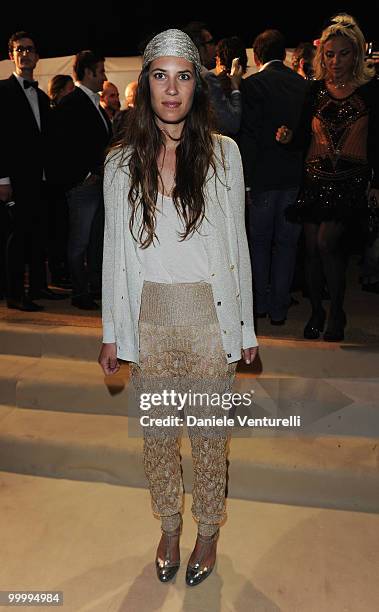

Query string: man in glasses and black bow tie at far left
[0,32,60,311]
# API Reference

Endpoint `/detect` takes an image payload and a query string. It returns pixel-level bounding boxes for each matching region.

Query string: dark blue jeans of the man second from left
[66,178,104,297]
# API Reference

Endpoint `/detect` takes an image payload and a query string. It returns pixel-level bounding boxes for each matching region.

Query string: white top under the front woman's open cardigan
[137,194,209,283]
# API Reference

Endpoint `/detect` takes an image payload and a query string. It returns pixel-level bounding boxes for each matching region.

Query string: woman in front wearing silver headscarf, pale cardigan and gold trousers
[99,30,257,586]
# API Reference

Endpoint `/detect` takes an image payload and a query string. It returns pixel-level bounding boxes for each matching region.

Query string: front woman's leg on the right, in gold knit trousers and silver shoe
[186,313,236,586]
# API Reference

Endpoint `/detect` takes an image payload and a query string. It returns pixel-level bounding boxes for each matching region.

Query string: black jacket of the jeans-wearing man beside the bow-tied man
[51,87,112,190]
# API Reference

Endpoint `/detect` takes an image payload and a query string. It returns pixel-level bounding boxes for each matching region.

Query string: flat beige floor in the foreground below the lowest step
[0,472,379,612]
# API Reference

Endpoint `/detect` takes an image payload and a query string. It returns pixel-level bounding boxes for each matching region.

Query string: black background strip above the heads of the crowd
[0,0,379,59]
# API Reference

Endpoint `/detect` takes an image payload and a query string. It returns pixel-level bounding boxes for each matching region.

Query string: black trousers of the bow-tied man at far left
[6,183,48,301]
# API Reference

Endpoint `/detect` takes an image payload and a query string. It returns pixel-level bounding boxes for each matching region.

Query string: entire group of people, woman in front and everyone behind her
[0,14,379,586]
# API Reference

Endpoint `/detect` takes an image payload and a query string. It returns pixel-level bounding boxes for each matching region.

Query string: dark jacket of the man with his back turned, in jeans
[238,61,309,192]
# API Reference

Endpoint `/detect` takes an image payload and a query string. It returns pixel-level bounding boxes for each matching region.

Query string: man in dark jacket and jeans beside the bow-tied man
[53,51,112,310]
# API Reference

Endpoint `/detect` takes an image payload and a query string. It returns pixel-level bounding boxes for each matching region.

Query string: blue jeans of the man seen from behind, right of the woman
[248,188,301,320]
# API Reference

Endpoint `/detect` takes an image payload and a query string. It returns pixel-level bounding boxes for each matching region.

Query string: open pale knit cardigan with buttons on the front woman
[102,135,258,364]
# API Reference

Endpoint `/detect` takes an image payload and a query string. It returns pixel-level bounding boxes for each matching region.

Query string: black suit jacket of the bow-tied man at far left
[0,75,50,201]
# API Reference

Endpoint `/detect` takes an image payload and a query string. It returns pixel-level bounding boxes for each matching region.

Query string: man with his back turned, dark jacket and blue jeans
[239,30,307,325]
